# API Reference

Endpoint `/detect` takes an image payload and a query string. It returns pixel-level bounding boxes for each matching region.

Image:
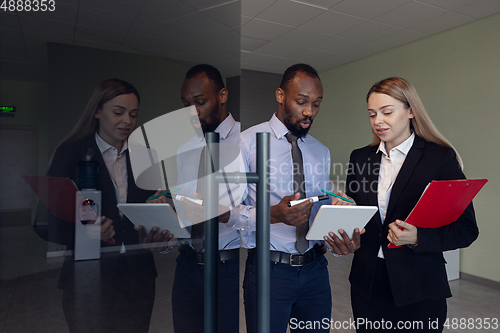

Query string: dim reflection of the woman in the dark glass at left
[40,79,172,333]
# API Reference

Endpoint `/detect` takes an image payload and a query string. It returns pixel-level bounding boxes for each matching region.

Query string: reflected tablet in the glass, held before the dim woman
[117,203,191,238]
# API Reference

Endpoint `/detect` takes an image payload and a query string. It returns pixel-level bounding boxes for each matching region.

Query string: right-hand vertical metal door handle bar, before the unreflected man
[256,133,271,333]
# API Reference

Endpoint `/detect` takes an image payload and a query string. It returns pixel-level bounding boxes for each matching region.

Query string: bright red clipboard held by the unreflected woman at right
[389,179,488,249]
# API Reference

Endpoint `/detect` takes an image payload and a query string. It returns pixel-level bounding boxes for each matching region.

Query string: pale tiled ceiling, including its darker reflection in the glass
[0,0,500,78]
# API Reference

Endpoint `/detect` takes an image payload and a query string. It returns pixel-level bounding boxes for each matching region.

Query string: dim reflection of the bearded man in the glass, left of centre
[151,64,244,333]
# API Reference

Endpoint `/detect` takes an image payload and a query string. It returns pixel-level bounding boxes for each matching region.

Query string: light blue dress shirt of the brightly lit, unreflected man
[235,114,331,253]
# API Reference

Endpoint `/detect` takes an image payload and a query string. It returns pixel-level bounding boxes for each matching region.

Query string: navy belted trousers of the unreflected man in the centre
[243,254,332,333]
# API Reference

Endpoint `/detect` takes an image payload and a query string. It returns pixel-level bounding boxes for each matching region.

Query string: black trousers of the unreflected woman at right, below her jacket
[351,258,447,333]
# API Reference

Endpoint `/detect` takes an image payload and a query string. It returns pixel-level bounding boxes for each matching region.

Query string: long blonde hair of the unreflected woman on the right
[366,77,463,169]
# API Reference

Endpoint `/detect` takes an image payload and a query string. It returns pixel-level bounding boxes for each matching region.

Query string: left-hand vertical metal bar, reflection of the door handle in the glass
[204,132,219,333]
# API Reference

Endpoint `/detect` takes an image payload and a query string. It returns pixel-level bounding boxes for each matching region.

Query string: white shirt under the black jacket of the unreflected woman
[377,133,415,259]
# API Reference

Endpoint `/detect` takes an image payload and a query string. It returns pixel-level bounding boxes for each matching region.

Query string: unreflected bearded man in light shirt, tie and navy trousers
[236,64,352,333]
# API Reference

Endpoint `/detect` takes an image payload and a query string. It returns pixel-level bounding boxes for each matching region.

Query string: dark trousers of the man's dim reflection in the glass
[172,253,240,333]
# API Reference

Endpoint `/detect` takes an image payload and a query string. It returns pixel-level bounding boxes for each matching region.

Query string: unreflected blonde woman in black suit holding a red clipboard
[327,77,479,332]
